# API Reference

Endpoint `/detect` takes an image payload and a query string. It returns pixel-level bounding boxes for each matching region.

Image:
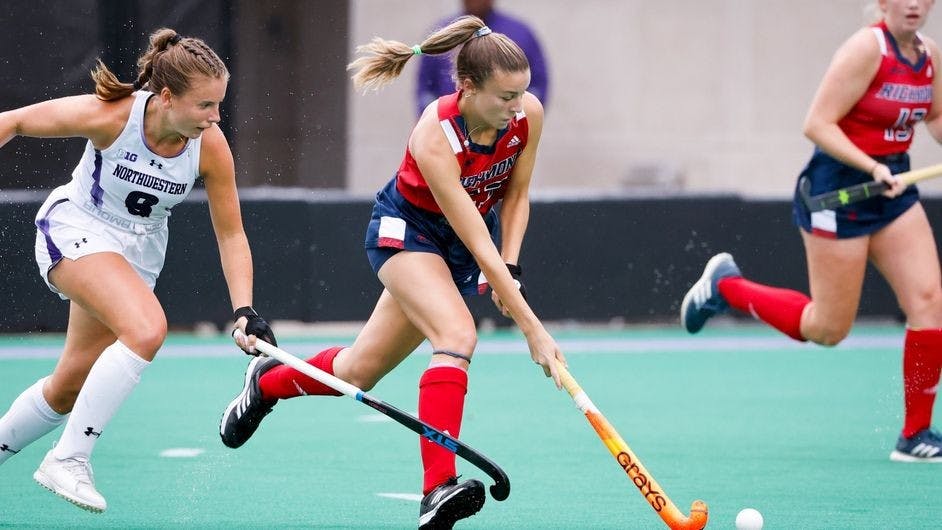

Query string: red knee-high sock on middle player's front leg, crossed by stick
[419,366,468,495]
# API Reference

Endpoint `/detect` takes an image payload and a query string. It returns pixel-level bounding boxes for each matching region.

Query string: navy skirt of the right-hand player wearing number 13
[792,148,919,239]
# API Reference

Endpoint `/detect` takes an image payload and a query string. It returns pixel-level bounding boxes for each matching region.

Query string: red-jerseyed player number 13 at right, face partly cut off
[681,0,942,462]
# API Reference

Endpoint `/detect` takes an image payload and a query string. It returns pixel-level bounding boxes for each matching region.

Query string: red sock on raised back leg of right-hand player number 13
[717,278,811,341]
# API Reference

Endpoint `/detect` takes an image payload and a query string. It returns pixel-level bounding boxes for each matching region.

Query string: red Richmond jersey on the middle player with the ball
[396,91,529,215]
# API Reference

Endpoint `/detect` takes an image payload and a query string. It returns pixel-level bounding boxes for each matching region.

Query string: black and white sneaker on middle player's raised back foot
[219,357,281,449]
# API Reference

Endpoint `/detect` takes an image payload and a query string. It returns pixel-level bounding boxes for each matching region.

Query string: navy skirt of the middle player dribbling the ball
[365,177,500,295]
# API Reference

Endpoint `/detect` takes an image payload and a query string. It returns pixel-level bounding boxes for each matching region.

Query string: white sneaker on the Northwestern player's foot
[33,450,108,513]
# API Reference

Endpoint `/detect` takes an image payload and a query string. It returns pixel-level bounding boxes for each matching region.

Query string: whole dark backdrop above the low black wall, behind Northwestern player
[0,0,348,190]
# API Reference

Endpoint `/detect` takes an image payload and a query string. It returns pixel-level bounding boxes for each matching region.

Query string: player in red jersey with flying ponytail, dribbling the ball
[220,17,565,528]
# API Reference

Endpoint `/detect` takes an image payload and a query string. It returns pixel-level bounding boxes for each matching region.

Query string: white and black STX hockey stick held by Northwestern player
[236,330,510,501]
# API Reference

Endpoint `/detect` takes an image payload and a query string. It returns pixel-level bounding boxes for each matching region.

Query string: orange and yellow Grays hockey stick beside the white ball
[556,361,709,530]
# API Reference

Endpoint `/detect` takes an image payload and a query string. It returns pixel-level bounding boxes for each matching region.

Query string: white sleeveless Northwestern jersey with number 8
[64,90,202,225]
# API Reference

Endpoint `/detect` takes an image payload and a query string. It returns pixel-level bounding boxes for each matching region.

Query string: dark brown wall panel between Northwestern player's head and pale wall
[231,0,348,188]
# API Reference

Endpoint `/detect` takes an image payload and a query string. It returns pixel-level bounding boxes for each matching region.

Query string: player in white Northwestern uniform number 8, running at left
[0,28,274,512]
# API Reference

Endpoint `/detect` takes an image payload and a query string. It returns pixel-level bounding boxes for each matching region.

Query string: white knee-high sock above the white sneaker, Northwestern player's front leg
[53,341,150,461]
